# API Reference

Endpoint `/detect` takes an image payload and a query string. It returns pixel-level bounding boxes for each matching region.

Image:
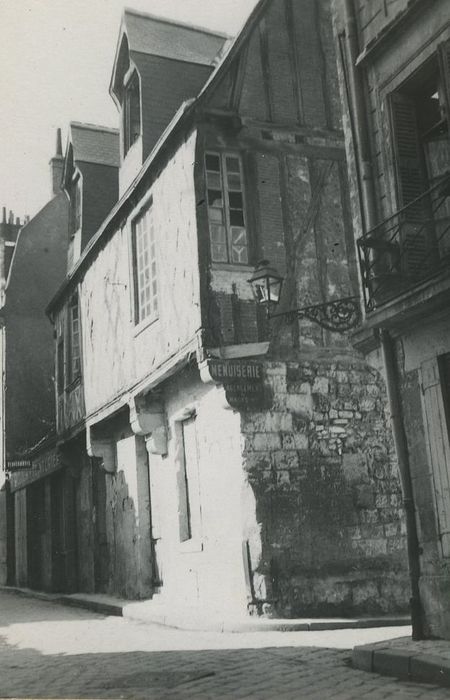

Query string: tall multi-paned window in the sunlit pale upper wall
[132,200,159,326]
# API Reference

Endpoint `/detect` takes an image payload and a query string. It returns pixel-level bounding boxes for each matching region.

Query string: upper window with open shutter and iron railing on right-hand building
[389,42,450,276]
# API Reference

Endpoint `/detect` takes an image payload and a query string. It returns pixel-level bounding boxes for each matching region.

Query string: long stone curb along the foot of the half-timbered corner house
[0,586,410,632]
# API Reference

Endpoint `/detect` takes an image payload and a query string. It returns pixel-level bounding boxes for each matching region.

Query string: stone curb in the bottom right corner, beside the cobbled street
[352,644,450,688]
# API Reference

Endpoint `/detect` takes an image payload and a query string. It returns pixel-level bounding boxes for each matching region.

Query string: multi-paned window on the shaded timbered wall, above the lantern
[205,152,249,265]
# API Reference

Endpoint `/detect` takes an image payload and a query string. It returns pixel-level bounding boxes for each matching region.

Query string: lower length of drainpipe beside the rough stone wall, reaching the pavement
[380,330,424,640]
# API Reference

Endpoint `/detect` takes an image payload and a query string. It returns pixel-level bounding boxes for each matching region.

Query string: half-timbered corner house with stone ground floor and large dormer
[6,0,407,622]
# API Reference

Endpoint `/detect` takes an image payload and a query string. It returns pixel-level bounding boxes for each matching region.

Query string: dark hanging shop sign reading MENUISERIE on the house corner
[208,360,269,411]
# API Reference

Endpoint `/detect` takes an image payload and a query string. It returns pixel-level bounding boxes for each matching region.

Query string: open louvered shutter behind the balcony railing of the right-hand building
[390,93,432,278]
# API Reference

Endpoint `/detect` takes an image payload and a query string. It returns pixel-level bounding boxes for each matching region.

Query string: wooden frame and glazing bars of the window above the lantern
[204,149,251,267]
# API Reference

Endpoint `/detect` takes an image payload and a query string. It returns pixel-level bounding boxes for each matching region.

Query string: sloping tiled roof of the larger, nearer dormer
[124,10,228,66]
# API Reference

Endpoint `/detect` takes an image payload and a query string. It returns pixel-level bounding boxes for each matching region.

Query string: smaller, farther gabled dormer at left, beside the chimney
[63,122,119,272]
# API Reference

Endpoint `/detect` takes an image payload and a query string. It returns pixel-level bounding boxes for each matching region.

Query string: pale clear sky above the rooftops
[0,0,257,219]
